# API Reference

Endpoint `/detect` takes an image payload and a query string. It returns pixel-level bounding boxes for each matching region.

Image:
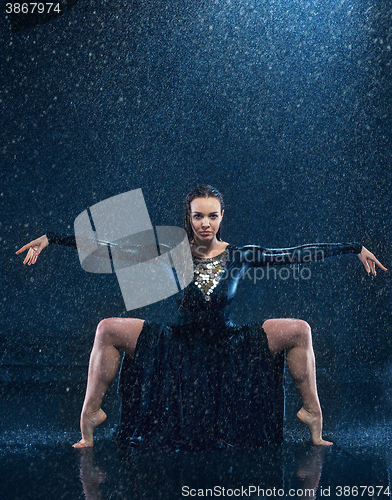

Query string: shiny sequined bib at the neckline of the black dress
[193,249,228,302]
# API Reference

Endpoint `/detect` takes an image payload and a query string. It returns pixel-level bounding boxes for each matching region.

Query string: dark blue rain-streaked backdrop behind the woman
[0,0,392,430]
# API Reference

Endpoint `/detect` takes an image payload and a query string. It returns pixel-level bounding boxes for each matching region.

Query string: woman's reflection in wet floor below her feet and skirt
[79,446,328,500]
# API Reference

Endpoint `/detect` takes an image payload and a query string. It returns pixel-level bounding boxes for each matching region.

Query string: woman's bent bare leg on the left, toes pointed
[73,318,144,448]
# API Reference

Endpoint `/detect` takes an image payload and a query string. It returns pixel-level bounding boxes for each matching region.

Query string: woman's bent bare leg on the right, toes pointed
[263,319,333,445]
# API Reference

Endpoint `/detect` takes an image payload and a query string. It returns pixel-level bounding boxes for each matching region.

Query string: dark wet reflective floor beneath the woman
[0,433,391,500]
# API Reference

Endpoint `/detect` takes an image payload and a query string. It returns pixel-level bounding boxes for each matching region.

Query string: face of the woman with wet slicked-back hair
[190,198,224,242]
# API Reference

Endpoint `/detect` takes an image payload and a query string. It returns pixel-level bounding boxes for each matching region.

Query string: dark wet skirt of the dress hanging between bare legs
[117,321,284,450]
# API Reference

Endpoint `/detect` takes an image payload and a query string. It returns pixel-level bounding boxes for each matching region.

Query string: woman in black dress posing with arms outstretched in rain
[16,185,386,448]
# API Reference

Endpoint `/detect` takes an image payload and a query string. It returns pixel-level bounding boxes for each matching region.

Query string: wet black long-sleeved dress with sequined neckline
[49,233,362,449]
